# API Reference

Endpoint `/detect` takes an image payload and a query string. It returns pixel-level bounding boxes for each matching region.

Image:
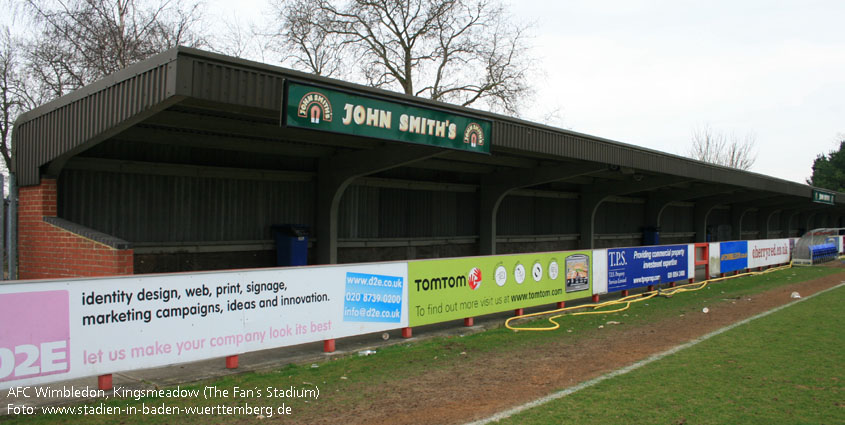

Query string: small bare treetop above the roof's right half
[688,126,757,170]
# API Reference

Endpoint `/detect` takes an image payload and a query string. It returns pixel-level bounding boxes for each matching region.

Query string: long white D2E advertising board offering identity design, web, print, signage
[0,263,408,389]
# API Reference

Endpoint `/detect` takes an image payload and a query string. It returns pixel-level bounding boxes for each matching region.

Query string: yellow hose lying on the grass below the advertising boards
[505,262,792,331]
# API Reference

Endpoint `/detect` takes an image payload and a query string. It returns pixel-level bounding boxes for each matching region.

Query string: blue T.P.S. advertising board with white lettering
[607,245,688,292]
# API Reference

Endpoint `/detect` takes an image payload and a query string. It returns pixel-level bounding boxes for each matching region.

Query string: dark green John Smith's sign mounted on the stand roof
[283,82,492,154]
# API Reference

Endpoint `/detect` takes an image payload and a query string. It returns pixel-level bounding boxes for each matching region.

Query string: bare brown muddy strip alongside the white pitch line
[286,262,845,424]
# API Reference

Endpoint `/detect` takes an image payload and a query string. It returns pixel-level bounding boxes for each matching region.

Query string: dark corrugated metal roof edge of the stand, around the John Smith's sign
[13,47,845,203]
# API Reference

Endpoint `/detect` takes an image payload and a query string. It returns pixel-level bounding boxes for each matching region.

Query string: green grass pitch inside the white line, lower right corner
[492,280,845,424]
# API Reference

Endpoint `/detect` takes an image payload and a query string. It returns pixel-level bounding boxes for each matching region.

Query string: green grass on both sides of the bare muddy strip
[0,267,845,425]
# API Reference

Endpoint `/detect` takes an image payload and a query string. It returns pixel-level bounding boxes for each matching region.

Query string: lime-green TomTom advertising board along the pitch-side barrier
[408,251,593,326]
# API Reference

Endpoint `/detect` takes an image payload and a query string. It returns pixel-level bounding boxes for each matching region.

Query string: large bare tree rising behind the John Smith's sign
[273,0,532,114]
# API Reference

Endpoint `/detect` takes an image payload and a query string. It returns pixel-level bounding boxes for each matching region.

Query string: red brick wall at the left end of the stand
[18,179,134,279]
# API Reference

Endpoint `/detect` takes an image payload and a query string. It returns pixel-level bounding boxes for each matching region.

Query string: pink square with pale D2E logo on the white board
[0,291,70,382]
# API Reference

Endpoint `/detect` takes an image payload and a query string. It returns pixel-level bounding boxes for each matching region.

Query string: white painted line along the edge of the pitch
[467,282,845,425]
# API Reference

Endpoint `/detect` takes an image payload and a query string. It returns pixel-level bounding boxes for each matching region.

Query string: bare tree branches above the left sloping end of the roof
[24,0,204,97]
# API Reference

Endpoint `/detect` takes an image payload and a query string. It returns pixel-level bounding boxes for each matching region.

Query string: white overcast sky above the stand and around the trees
[201,0,845,183]
